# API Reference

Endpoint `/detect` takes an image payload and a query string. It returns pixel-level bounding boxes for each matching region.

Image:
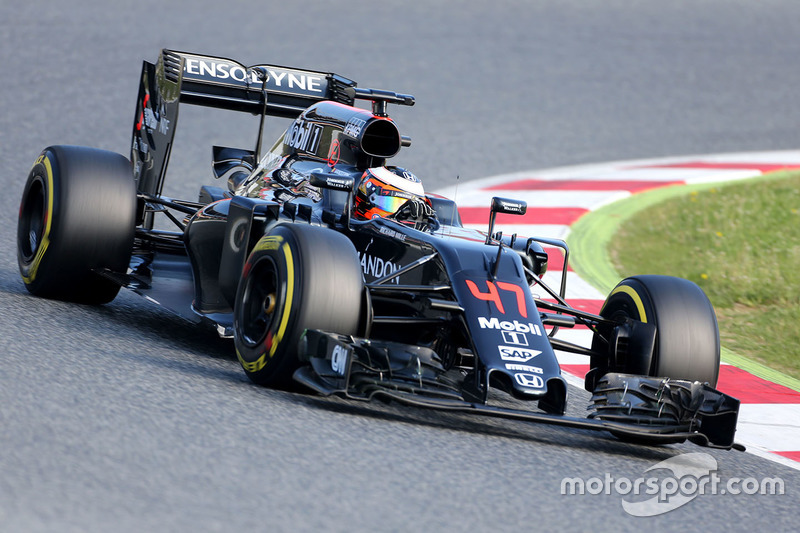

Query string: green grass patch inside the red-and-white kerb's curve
[607,172,800,378]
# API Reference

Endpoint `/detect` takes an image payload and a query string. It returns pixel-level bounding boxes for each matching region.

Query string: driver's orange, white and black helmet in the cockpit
[353,167,428,219]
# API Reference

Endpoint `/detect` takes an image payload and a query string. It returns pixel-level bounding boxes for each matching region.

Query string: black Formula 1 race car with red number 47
[18,50,741,449]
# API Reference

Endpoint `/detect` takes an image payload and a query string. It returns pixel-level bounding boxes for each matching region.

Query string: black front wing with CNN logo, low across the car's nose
[294,330,744,451]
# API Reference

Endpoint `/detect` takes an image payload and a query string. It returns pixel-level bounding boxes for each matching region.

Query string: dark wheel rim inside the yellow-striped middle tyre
[239,257,280,348]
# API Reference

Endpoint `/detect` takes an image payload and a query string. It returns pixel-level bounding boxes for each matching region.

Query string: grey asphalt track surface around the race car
[0,0,800,531]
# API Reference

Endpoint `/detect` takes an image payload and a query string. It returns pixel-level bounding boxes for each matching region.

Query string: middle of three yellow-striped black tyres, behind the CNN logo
[233,224,365,388]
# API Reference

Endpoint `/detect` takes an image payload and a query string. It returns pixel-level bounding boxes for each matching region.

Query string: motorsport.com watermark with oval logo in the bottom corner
[561,452,786,516]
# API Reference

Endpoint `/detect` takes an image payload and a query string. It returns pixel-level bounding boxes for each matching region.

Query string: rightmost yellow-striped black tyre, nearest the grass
[592,275,720,387]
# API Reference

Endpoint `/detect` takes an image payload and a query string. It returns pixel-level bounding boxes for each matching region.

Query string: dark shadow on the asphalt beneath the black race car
[0,272,700,461]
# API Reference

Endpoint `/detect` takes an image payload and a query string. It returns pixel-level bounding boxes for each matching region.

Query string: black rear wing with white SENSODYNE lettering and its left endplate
[131,49,356,195]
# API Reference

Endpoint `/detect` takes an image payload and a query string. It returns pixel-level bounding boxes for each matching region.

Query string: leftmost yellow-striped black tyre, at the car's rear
[17,146,136,304]
